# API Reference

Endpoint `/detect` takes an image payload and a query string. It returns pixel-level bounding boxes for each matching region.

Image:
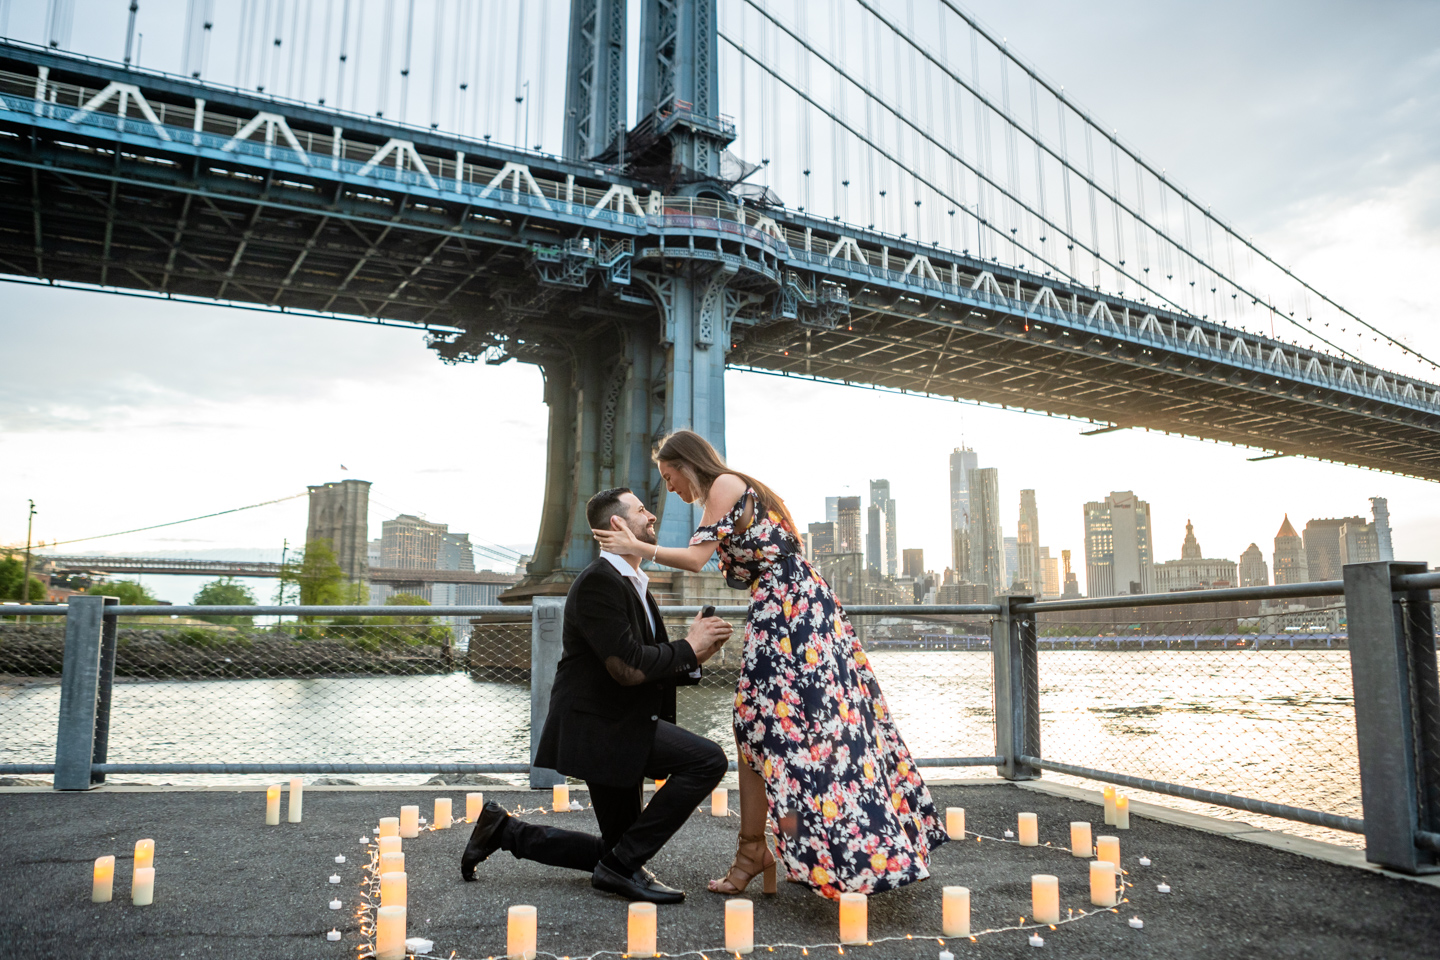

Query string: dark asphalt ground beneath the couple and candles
[0,784,1440,960]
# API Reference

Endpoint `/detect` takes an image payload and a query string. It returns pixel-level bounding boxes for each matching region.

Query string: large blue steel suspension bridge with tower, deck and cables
[0,0,1440,587]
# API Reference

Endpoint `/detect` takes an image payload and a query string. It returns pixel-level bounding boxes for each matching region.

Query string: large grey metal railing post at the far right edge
[1344,560,1440,874]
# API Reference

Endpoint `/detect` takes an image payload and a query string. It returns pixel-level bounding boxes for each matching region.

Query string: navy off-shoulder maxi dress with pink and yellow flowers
[690,489,948,900]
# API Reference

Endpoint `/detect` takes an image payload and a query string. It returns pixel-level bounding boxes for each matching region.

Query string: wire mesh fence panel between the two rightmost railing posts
[1037,602,1362,845]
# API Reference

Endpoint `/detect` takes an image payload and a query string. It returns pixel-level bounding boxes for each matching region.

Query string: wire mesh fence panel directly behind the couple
[665,616,995,777]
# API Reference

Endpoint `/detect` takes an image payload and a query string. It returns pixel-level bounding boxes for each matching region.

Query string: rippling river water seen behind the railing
[0,651,1361,843]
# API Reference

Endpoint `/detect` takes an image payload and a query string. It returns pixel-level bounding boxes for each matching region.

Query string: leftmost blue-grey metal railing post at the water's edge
[55,596,108,790]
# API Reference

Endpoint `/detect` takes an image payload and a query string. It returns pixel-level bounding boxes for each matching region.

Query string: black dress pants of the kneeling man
[500,720,729,872]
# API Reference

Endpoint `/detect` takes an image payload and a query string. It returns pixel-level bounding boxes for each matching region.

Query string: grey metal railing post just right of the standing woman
[991,597,1040,780]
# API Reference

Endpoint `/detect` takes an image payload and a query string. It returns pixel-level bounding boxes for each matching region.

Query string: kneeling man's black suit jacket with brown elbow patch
[534,558,700,786]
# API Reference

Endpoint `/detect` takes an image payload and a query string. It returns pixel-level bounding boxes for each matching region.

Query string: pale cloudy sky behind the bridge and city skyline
[0,0,1440,600]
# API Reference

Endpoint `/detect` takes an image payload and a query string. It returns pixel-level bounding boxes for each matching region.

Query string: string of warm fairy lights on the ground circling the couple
[354,802,1149,960]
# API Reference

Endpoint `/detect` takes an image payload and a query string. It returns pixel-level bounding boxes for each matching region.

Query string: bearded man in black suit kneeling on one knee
[461,488,730,904]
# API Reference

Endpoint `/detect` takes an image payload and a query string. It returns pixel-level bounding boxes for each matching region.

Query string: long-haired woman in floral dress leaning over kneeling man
[595,430,948,900]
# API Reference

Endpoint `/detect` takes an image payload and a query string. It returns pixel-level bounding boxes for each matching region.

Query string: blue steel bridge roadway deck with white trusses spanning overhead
[0,43,1440,479]
